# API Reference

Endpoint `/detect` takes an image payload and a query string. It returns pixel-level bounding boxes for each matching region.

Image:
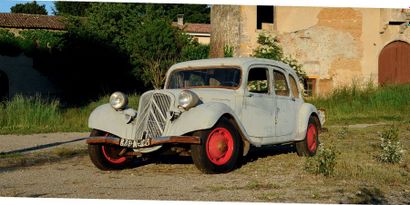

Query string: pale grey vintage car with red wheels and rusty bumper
[87,58,324,173]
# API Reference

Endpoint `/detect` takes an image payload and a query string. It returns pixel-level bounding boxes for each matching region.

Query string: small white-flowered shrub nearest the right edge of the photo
[377,126,404,164]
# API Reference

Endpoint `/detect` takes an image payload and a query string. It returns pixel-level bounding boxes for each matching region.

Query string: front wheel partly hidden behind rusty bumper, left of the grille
[88,129,131,170]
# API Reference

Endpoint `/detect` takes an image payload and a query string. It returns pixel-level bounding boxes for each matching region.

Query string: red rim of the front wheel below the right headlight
[206,127,234,165]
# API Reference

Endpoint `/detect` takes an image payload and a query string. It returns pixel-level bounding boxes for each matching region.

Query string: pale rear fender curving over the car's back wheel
[295,103,322,141]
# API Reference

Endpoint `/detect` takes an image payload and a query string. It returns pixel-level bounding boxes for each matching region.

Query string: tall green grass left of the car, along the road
[0,94,139,134]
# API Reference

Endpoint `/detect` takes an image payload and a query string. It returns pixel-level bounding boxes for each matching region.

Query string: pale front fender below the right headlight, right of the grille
[166,102,239,136]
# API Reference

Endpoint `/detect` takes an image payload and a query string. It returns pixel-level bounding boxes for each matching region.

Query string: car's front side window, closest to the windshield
[248,68,269,93]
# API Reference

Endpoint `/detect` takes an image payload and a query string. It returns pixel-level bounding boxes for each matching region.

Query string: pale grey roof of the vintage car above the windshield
[168,57,296,75]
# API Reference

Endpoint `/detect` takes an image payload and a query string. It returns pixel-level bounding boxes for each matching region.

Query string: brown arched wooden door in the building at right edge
[379,41,410,85]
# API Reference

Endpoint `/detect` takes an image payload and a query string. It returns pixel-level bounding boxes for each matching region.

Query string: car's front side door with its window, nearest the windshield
[241,65,275,137]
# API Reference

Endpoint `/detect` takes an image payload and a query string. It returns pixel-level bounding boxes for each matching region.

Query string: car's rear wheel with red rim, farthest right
[295,115,320,157]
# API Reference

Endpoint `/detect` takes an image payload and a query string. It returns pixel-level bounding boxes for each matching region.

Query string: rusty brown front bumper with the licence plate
[86,136,201,149]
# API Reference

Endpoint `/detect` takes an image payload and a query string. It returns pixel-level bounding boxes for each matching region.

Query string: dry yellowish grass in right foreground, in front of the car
[231,122,410,204]
